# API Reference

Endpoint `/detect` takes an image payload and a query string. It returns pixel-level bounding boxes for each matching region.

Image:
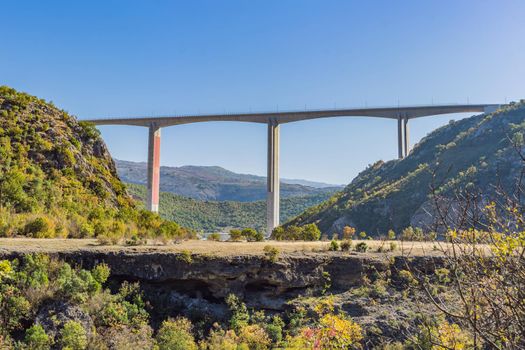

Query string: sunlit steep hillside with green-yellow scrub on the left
[0,86,194,239]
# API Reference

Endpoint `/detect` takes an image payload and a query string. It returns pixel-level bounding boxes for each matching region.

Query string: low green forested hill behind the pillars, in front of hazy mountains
[127,184,331,232]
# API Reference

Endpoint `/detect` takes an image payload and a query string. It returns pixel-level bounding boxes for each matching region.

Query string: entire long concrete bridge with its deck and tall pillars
[82,104,499,233]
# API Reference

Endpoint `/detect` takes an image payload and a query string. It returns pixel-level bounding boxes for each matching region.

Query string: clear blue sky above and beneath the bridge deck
[0,0,525,183]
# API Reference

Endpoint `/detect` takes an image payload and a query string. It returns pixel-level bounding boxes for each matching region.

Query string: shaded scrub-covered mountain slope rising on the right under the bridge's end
[288,100,525,235]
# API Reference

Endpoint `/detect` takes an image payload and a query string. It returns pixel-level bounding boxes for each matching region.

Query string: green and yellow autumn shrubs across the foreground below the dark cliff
[0,253,486,350]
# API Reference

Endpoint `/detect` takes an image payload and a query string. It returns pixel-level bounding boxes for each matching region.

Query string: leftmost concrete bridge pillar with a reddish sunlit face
[146,124,160,213]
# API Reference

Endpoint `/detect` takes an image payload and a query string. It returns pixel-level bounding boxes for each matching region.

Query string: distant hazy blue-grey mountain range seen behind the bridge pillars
[115,159,342,202]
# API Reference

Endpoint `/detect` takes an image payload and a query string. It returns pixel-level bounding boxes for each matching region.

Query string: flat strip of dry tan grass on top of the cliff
[0,238,456,256]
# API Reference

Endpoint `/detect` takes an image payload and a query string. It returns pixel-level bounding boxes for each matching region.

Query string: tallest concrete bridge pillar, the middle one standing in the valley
[266,120,279,235]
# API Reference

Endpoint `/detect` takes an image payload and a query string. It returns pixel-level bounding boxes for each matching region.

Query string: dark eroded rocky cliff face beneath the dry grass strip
[0,250,441,330]
